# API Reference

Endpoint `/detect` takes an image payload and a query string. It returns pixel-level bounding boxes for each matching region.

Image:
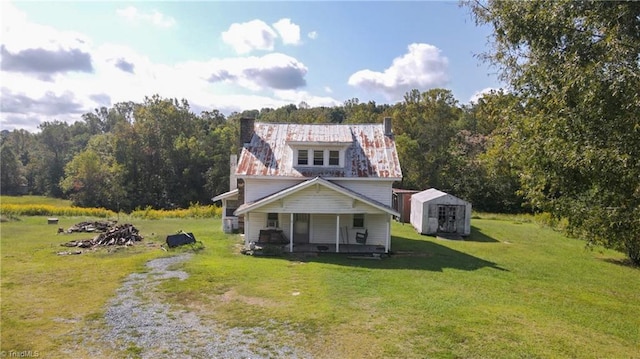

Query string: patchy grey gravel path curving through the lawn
[97,254,308,359]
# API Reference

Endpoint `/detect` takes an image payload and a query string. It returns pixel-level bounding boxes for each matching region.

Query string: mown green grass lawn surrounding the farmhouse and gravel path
[0,210,640,358]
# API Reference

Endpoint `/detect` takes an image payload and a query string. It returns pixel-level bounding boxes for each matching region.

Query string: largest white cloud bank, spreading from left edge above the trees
[0,4,340,131]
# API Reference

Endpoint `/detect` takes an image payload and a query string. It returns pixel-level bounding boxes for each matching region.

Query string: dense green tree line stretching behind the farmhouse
[1,89,525,212]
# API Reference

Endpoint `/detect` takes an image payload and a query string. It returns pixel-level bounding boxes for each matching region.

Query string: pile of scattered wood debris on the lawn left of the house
[61,222,143,252]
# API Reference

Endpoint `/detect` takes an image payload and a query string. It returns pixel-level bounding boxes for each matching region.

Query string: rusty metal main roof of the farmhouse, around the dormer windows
[236,122,402,180]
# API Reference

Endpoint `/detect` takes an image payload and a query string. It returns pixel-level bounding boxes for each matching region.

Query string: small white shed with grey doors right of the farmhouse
[411,188,471,236]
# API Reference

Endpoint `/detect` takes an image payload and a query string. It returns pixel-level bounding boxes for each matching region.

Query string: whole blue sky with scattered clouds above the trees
[0,1,501,131]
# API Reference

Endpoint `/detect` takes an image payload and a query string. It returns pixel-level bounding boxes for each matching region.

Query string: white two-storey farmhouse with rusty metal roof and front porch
[213,118,402,253]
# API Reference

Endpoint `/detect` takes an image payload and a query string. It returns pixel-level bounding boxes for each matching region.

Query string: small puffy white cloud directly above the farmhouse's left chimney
[222,20,278,54]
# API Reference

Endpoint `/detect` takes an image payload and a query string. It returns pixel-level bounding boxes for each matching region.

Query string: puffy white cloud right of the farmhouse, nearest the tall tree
[349,43,449,100]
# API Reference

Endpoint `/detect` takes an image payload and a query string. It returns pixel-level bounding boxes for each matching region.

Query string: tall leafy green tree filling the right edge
[468,0,640,264]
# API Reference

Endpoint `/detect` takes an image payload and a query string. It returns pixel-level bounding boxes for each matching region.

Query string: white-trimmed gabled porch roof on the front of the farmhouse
[234,177,400,216]
